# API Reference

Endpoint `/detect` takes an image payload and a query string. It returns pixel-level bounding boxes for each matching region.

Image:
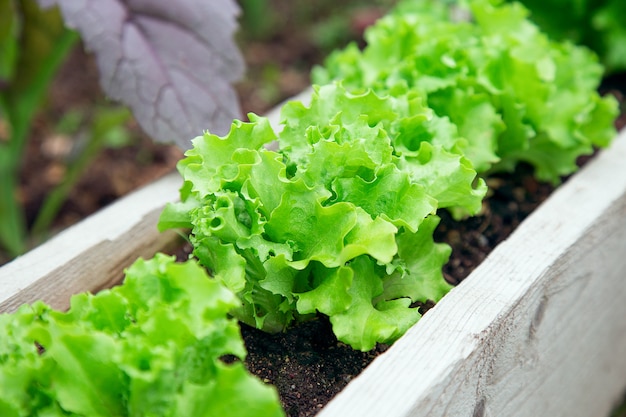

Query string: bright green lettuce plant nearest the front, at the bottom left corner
[0,254,284,417]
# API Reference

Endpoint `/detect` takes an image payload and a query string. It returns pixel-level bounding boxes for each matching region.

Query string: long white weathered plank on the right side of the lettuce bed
[318,128,626,417]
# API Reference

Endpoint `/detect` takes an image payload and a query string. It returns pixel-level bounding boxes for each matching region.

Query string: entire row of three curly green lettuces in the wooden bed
[0,0,617,417]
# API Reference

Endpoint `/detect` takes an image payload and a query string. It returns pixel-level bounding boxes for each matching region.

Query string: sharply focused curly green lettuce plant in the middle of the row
[159,84,486,350]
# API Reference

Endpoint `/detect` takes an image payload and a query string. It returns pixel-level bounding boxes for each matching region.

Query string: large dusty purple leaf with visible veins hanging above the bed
[39,0,244,149]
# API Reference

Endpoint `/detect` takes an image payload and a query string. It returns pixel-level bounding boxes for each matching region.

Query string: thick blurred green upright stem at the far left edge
[0,1,78,257]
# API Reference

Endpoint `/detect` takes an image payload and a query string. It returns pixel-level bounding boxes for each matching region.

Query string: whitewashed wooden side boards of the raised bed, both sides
[0,93,626,417]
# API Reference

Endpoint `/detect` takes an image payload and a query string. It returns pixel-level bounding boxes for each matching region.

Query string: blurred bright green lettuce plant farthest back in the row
[313,0,617,183]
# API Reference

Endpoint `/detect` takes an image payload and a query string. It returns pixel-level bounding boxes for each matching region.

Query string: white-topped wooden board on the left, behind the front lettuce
[0,173,182,312]
